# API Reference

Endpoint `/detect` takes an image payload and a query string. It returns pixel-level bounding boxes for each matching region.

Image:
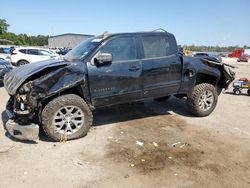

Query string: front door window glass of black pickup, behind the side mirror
[101,37,136,61]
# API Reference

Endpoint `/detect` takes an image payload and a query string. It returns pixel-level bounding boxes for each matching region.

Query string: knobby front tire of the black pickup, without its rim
[42,94,93,141]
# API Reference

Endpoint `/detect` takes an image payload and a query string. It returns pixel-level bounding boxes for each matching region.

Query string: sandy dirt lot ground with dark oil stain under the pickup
[0,59,250,188]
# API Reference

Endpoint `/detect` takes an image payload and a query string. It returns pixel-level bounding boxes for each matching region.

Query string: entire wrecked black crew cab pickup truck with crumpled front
[4,32,234,141]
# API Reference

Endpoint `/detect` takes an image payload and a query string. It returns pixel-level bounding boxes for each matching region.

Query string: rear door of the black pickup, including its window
[141,34,182,98]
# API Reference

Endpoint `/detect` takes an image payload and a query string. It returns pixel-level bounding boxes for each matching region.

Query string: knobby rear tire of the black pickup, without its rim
[188,83,218,117]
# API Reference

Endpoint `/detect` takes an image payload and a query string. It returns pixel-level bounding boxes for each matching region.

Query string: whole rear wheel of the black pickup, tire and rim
[188,83,218,117]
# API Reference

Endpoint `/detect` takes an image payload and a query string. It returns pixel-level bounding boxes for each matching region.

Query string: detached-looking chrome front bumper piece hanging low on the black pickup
[6,119,39,140]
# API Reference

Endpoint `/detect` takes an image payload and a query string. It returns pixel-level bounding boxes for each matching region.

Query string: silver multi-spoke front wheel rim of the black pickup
[53,106,84,135]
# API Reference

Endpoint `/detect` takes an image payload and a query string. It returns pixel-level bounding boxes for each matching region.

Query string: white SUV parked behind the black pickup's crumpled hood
[10,47,60,66]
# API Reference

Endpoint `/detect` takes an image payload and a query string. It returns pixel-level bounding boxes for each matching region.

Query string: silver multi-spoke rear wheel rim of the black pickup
[199,90,214,111]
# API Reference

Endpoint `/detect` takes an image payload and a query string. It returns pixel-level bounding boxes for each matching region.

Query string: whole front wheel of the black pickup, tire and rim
[42,94,93,141]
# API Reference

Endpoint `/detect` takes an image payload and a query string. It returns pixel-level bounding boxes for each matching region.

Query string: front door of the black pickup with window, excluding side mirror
[87,36,142,106]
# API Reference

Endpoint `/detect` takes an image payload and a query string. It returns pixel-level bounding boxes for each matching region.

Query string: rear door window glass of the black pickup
[142,36,172,58]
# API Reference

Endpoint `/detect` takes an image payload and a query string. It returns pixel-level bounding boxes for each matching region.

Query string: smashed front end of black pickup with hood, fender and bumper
[4,61,88,140]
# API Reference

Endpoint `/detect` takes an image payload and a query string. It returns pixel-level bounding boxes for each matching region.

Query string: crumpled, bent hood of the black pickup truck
[4,60,68,95]
